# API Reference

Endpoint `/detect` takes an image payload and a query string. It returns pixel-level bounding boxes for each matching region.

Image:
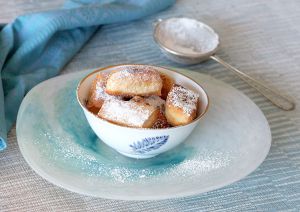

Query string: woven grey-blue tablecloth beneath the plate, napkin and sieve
[0,0,300,211]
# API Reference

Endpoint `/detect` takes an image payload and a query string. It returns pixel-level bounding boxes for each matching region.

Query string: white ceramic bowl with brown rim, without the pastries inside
[77,64,209,158]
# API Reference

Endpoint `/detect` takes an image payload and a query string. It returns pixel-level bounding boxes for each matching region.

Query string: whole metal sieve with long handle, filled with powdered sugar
[153,18,295,111]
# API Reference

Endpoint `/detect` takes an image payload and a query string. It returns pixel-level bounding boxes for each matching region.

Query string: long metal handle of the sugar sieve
[210,55,295,111]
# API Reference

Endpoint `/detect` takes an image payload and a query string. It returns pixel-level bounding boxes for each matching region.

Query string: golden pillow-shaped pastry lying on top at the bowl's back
[106,67,162,96]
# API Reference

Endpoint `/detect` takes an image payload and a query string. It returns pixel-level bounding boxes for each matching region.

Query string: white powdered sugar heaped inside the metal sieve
[157,18,219,54]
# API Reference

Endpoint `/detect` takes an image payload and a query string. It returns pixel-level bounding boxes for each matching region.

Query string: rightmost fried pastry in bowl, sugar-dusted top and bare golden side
[165,84,199,126]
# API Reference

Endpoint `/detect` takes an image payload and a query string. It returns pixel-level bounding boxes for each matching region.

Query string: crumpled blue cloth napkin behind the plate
[0,0,175,150]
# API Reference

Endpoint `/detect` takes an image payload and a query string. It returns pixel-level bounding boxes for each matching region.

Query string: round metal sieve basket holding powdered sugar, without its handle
[153,18,220,64]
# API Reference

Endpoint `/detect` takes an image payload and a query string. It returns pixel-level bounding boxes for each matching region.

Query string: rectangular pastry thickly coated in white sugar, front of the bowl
[98,99,159,128]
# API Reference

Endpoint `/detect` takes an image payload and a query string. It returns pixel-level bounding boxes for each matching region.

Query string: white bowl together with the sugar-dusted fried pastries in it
[77,64,209,158]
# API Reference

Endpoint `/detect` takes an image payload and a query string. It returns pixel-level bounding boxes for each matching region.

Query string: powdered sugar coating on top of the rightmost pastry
[167,85,199,116]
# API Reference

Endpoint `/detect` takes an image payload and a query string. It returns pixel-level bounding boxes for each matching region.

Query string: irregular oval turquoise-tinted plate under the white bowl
[17,70,271,200]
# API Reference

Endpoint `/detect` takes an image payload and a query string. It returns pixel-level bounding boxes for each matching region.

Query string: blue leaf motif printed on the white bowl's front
[129,135,169,154]
